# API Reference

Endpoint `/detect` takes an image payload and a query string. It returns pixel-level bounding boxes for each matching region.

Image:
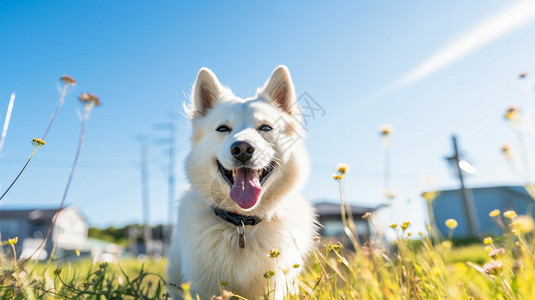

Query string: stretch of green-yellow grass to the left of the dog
[0,252,168,299]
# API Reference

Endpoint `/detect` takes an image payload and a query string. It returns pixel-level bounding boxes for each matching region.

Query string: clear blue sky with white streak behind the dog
[0,1,535,226]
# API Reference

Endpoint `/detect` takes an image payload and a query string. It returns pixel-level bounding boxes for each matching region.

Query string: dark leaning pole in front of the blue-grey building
[448,135,479,236]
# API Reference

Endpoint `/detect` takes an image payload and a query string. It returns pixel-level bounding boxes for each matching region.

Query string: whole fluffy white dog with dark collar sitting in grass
[167,66,317,299]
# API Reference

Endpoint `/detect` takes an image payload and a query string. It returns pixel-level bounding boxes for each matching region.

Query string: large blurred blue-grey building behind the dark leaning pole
[431,186,535,237]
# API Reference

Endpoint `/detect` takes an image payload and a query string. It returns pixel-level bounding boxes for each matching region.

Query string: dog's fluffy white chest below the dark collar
[183,214,303,295]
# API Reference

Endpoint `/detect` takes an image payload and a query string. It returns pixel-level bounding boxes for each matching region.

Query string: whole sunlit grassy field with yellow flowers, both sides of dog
[0,215,535,299]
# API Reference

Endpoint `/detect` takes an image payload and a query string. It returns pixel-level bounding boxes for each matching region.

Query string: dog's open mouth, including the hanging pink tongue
[217,161,274,209]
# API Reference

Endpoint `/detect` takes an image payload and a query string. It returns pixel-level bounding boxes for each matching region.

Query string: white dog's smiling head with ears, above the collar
[186,66,308,215]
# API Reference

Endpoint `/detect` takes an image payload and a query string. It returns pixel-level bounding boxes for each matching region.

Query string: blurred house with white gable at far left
[0,206,88,259]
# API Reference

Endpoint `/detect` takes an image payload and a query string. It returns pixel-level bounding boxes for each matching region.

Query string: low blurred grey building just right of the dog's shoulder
[314,202,375,241]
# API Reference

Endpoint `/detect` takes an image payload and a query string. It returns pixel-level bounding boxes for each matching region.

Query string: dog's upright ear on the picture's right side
[261,65,296,114]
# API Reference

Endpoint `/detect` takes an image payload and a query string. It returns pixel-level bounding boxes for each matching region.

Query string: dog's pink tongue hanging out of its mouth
[230,168,262,209]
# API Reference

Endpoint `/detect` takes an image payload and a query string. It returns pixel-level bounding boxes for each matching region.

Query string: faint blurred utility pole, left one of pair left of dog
[138,136,152,256]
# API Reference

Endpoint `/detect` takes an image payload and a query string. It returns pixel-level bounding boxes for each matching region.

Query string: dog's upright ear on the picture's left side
[193,68,222,115]
